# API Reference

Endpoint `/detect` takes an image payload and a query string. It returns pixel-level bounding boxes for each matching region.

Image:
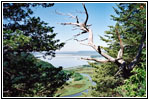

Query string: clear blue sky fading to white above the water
[33,3,116,51]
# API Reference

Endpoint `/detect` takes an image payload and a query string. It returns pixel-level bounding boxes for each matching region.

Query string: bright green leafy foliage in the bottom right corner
[116,49,146,97]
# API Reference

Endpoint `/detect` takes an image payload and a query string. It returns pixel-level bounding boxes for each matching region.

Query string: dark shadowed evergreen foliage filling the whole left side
[3,3,70,97]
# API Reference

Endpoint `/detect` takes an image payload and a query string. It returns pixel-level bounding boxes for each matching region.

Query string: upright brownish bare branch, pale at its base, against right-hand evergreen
[115,28,124,59]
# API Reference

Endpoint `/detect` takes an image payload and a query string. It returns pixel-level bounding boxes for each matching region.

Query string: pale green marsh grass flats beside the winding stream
[56,67,94,96]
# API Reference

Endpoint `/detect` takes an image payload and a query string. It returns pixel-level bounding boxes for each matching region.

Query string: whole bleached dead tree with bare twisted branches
[60,4,146,76]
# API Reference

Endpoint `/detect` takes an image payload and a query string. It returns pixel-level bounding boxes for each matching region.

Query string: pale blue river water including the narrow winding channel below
[33,52,97,97]
